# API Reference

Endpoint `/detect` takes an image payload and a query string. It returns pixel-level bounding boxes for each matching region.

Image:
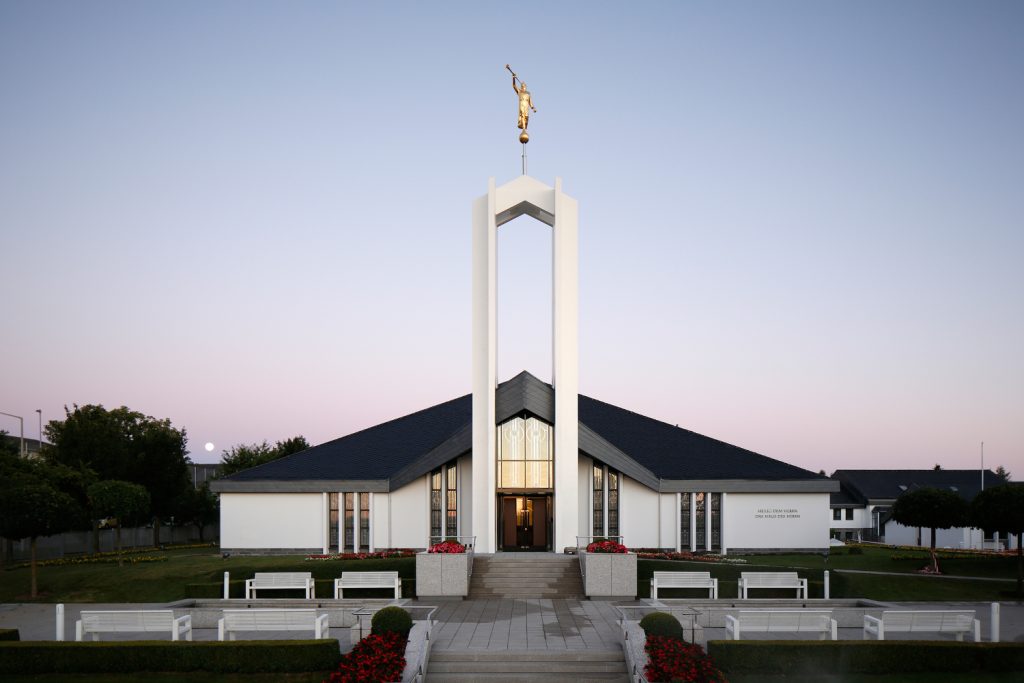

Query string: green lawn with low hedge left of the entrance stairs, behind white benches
[0,548,416,602]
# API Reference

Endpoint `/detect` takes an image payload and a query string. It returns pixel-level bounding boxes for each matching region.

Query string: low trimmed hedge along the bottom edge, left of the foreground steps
[0,639,341,677]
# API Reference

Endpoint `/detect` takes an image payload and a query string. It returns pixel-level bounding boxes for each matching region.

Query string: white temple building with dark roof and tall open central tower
[213,175,839,554]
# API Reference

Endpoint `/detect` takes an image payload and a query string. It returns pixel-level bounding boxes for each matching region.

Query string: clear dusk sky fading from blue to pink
[0,0,1024,479]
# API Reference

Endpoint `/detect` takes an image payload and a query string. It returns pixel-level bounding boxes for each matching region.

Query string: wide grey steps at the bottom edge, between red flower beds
[426,649,630,683]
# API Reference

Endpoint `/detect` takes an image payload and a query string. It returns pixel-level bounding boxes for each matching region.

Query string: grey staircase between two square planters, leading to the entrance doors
[469,553,584,600]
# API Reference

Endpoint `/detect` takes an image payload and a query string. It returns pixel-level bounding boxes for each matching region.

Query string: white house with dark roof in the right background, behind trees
[829,470,1014,549]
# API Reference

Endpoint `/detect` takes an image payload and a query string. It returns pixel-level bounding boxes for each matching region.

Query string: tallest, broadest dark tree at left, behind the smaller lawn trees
[46,405,189,545]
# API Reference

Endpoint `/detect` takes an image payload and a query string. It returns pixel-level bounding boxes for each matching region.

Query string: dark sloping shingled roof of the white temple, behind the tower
[214,373,822,489]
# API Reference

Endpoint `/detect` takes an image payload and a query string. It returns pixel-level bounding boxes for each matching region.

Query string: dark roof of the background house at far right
[833,470,1006,503]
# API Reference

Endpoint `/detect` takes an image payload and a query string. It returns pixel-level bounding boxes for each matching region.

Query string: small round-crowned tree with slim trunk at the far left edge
[0,472,76,598]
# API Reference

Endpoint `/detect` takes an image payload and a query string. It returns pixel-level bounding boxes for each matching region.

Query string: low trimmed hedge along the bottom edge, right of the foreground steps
[708,640,1024,675]
